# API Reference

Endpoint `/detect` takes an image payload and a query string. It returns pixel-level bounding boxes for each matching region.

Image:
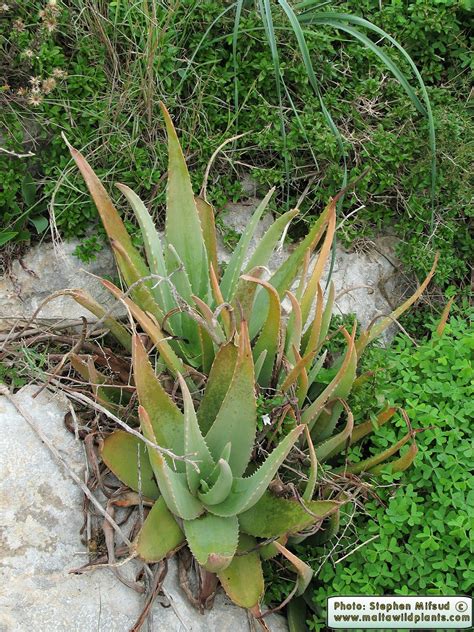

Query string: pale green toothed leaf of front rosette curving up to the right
[206,424,304,516]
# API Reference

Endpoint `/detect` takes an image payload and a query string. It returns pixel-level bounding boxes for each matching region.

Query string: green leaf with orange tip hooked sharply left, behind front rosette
[241,275,281,387]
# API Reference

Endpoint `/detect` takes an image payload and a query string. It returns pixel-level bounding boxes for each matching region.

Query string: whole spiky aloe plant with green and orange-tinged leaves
[64,106,436,614]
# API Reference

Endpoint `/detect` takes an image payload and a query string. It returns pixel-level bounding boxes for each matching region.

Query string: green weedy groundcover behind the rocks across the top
[0,0,472,288]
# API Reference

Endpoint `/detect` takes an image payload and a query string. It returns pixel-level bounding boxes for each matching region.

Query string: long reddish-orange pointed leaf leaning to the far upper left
[66,141,149,276]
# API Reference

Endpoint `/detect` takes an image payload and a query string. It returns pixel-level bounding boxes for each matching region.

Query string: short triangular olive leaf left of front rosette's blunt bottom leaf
[134,498,185,563]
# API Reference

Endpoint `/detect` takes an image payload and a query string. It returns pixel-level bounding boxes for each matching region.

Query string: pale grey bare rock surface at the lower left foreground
[0,385,287,632]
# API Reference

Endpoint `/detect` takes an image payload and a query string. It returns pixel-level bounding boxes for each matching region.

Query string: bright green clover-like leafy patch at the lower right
[299,306,474,630]
